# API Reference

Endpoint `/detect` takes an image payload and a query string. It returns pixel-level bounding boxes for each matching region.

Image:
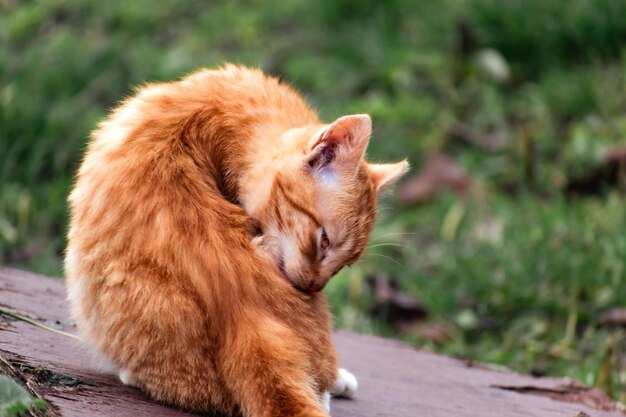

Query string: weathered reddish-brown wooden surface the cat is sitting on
[0,268,624,417]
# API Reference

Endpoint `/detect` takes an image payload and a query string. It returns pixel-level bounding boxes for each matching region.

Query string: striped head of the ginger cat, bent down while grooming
[249,115,408,292]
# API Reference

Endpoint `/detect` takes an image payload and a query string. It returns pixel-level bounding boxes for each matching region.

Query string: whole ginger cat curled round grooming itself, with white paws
[65,65,408,417]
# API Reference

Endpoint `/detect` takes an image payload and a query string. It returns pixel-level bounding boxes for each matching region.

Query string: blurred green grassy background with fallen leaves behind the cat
[0,0,626,401]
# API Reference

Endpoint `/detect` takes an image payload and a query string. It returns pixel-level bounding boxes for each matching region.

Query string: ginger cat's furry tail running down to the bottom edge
[221,312,328,417]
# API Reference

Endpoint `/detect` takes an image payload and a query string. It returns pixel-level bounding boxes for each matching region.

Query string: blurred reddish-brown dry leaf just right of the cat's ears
[399,154,473,204]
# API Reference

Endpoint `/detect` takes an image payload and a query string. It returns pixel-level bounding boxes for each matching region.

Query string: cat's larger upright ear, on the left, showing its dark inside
[309,114,372,168]
